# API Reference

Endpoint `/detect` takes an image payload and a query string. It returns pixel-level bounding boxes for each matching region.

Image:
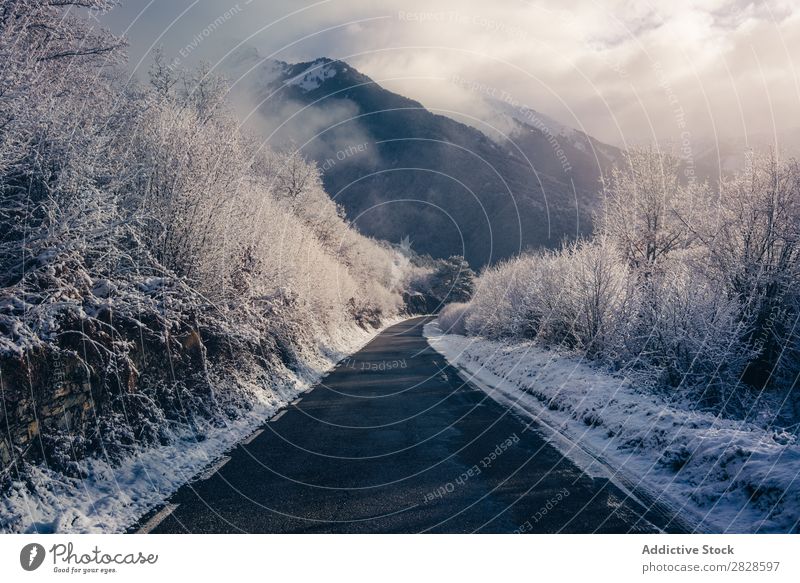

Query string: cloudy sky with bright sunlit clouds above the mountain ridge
[100,0,800,149]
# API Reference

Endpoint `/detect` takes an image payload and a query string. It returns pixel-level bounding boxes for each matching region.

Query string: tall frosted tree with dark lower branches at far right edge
[699,152,800,384]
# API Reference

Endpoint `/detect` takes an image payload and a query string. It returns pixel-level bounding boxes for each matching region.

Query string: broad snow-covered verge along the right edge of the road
[425,322,800,532]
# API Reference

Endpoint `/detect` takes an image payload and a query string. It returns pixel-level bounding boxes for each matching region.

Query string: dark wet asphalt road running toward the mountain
[139,318,675,533]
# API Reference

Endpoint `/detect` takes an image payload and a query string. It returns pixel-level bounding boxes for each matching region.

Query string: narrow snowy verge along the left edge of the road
[0,318,403,533]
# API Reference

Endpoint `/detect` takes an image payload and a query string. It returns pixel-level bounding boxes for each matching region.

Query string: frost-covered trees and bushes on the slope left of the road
[0,0,412,460]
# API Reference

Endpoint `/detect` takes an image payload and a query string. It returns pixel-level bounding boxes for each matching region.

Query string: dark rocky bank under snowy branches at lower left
[0,313,219,474]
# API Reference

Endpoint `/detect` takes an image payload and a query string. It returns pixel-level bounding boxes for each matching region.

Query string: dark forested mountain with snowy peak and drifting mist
[222,51,619,268]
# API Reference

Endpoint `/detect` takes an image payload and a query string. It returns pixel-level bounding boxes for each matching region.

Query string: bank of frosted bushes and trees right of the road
[458,149,800,405]
